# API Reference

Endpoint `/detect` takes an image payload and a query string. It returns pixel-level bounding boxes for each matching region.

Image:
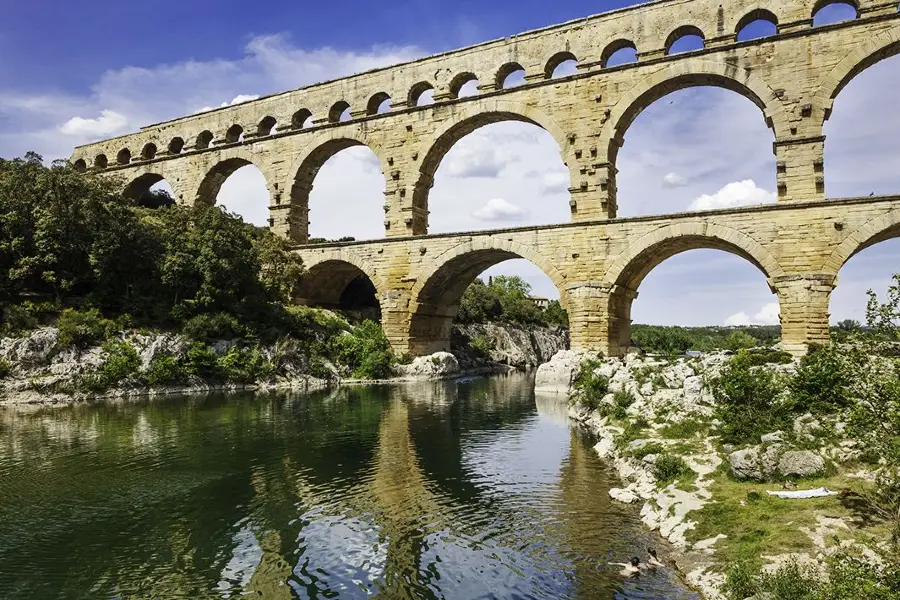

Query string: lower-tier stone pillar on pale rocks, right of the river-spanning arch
[567,282,638,356]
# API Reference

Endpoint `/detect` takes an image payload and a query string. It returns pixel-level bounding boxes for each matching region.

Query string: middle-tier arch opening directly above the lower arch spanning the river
[413,112,571,233]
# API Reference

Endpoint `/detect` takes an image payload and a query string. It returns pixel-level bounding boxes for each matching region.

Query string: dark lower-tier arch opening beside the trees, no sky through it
[295,259,381,322]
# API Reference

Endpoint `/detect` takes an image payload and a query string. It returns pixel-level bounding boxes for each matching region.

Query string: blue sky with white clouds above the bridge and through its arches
[0,0,900,325]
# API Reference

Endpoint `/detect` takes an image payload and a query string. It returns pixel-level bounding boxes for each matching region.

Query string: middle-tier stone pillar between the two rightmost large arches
[775,136,825,202]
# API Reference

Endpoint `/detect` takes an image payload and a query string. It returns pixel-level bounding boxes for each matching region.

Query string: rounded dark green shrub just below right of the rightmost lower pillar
[789,346,852,414]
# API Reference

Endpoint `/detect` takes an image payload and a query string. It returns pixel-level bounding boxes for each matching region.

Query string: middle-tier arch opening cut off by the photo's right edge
[823,42,900,198]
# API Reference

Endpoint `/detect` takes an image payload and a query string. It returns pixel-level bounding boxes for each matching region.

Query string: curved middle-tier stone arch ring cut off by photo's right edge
[812,25,900,125]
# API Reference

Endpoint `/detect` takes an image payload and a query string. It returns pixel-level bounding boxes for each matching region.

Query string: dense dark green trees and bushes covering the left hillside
[0,154,393,380]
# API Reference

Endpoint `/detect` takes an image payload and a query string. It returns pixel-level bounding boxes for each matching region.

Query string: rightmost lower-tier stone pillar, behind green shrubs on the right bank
[772,273,837,355]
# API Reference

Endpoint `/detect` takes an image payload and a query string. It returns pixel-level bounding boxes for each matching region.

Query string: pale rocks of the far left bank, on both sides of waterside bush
[0,317,568,404]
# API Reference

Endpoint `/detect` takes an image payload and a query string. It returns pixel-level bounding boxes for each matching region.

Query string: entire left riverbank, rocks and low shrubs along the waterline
[0,316,567,404]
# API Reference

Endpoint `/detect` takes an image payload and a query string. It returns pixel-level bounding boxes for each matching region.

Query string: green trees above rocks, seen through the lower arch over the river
[456,275,569,327]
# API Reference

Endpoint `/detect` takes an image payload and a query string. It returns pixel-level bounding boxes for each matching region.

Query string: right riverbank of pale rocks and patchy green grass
[536,352,890,600]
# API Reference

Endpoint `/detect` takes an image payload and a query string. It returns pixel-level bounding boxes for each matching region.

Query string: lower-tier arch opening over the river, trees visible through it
[409,248,566,355]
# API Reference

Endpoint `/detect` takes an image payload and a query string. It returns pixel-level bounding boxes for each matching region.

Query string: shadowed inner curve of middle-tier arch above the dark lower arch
[289,132,388,244]
